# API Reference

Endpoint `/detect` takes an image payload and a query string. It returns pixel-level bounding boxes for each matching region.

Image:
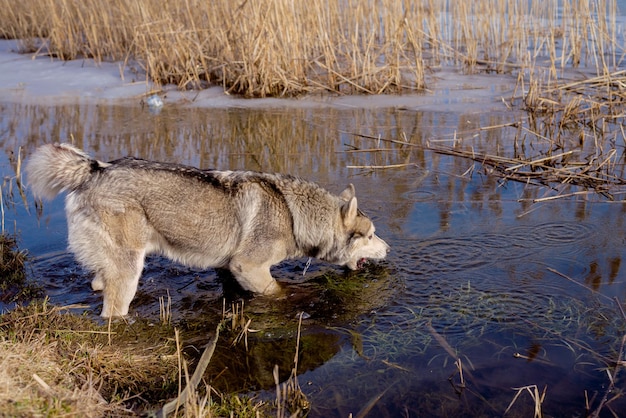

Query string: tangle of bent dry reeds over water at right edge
[500,67,626,199]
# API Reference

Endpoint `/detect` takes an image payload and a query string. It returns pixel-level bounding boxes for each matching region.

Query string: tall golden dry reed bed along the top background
[0,0,624,97]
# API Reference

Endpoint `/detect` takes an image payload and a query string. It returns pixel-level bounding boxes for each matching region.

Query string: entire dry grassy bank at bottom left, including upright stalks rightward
[0,301,308,418]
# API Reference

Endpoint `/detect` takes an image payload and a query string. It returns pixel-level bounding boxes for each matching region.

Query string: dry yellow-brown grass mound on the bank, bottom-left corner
[0,302,195,417]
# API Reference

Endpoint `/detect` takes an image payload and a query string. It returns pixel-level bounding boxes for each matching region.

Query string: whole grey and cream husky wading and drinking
[26,144,389,318]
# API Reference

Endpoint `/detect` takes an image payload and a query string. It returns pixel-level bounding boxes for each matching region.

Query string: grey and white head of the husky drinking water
[335,184,389,270]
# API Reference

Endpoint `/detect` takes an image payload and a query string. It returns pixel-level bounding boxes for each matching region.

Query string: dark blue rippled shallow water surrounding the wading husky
[0,99,626,417]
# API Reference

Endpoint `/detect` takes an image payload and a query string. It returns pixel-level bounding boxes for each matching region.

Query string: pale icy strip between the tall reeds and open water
[0,40,515,112]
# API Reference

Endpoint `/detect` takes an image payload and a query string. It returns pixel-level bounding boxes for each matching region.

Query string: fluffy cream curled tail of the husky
[26,144,108,199]
